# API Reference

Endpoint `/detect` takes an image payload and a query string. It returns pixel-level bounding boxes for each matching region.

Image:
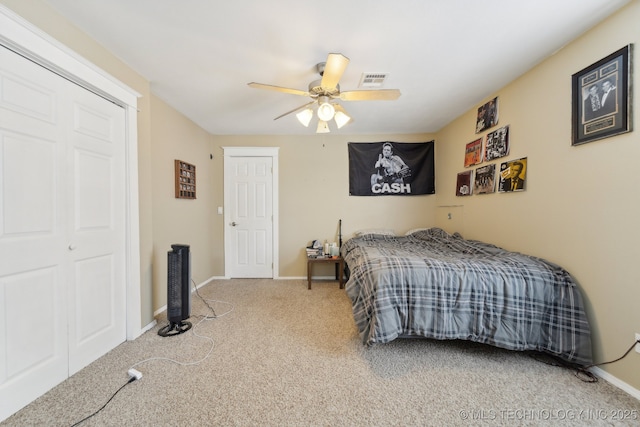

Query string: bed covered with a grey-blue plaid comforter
[341,228,592,366]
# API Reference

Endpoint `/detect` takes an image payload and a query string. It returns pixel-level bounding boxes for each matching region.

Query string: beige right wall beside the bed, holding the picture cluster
[436,1,640,389]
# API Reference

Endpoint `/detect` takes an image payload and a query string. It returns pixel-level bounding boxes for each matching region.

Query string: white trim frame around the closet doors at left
[0,5,143,340]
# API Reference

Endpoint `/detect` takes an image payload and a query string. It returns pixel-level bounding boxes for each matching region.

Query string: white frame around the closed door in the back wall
[222,147,280,279]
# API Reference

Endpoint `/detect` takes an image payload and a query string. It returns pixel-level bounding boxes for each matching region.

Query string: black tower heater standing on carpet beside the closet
[158,245,191,337]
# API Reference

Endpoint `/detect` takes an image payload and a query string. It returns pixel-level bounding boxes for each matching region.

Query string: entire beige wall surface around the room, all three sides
[0,0,640,389]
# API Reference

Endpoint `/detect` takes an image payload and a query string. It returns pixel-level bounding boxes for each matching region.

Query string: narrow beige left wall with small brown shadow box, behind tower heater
[151,95,218,310]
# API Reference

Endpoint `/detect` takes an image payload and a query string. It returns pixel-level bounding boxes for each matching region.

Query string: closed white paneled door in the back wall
[225,157,273,278]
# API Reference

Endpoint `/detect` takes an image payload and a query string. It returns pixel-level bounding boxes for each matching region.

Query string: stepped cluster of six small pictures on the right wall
[456,97,527,196]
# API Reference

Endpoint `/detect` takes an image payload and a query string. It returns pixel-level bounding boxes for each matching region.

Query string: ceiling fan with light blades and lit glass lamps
[248,53,400,133]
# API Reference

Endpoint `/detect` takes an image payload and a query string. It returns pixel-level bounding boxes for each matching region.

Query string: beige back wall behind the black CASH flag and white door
[212,135,437,277]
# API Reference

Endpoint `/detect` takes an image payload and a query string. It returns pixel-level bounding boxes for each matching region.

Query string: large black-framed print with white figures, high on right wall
[571,45,632,145]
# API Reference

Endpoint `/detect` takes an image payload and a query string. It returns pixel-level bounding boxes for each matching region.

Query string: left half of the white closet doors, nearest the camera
[0,47,69,419]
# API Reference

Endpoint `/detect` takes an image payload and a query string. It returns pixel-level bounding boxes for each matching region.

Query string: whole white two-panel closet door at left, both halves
[0,46,126,420]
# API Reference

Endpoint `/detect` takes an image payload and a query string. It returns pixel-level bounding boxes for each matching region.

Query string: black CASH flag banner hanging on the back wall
[349,141,436,196]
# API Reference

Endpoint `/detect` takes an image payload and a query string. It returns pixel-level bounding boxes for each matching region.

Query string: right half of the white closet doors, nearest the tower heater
[66,79,126,374]
